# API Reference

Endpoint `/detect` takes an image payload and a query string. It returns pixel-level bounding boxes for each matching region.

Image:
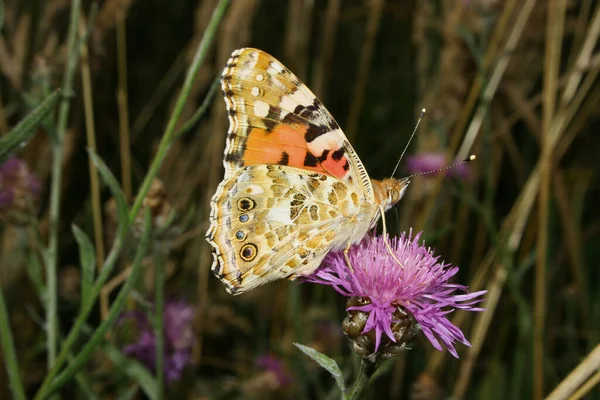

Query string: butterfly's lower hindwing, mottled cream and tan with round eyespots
[208,165,359,294]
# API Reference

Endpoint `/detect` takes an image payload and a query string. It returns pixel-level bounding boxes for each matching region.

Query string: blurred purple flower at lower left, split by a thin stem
[120,301,194,382]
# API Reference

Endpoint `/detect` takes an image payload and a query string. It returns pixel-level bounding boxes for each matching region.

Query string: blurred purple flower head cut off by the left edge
[0,156,41,222]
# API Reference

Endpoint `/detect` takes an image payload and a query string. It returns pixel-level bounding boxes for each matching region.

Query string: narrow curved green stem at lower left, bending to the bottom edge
[35,211,152,399]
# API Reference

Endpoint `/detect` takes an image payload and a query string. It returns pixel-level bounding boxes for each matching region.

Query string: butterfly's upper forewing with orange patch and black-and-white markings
[221,49,351,179]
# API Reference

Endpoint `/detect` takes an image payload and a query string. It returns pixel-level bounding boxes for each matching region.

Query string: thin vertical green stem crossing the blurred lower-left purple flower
[154,244,165,399]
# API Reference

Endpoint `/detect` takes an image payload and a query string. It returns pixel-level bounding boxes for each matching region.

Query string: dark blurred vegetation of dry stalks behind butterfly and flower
[0,0,600,400]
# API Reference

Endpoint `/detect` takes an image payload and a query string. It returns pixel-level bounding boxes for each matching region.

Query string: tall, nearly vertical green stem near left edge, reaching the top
[46,0,81,370]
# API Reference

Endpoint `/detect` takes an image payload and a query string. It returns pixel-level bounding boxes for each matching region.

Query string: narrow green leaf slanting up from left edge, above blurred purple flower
[0,90,60,163]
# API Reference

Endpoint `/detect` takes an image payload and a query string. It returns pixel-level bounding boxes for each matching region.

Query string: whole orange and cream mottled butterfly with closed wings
[206,48,409,294]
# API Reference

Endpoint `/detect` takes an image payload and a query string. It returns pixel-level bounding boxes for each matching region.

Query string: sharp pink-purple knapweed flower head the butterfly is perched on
[306,232,486,358]
